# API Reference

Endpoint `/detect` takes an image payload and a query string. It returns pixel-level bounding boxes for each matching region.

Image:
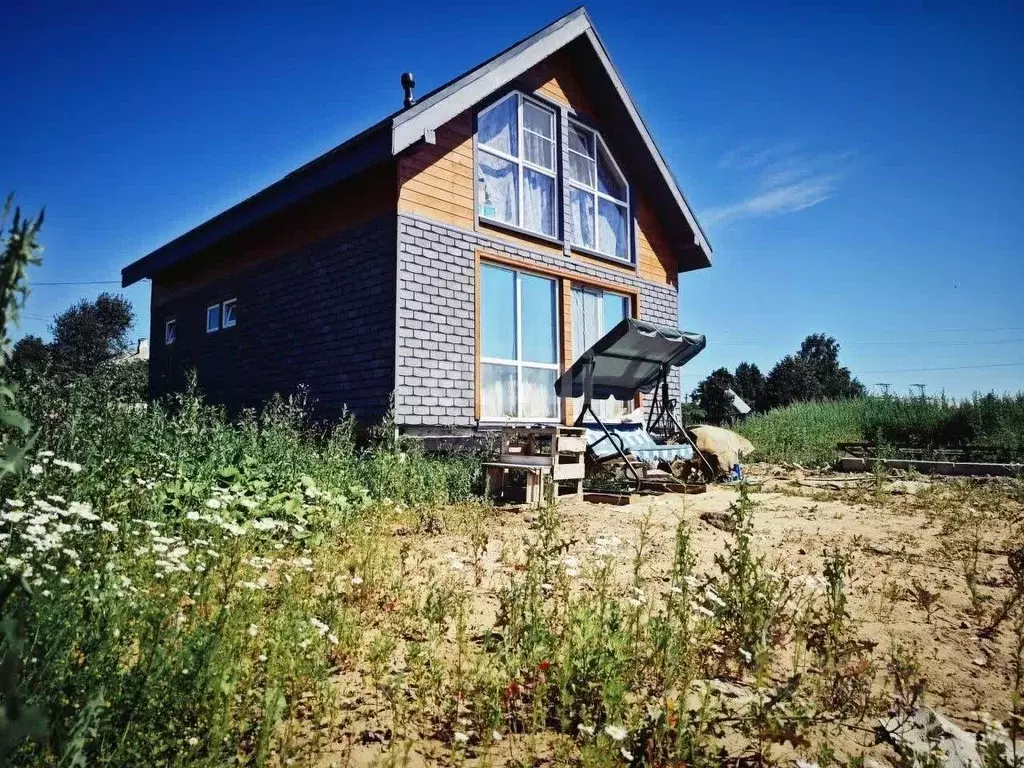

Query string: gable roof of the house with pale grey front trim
[121,7,712,286]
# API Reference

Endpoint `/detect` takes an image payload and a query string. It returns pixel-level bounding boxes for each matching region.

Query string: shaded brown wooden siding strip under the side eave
[153,163,395,307]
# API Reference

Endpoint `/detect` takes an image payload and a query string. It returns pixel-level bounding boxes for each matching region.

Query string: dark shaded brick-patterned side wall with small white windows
[150,214,396,423]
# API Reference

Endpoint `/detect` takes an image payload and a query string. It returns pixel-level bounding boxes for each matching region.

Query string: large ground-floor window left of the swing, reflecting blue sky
[478,264,559,421]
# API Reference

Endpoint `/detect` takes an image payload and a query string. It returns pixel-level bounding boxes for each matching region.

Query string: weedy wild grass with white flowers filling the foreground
[6,372,1024,766]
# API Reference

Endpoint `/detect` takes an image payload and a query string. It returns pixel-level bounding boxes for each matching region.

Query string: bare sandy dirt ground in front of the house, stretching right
[417,466,1022,728]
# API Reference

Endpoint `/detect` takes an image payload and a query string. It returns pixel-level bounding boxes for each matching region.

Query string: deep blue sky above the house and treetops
[0,0,1024,397]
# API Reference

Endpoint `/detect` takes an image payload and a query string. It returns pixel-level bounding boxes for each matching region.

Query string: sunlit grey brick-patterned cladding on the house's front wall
[395,214,679,429]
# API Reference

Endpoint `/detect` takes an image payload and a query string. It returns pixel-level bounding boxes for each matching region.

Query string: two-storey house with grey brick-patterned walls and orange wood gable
[122,8,711,434]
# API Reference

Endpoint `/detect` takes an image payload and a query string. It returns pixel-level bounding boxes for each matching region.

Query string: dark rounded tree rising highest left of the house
[50,293,135,377]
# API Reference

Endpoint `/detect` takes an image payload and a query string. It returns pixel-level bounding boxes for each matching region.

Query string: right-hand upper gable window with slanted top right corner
[565,122,631,261]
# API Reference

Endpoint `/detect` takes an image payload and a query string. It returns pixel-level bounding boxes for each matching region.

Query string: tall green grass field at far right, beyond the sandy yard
[737,394,1024,465]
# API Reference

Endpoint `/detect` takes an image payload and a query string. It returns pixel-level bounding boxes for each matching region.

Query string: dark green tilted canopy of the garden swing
[555,317,708,400]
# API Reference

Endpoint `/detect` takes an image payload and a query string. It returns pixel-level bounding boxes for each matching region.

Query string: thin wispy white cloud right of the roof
[702,143,853,224]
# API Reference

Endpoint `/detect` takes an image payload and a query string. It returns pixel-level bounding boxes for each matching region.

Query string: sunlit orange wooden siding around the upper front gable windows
[398,49,678,286]
